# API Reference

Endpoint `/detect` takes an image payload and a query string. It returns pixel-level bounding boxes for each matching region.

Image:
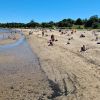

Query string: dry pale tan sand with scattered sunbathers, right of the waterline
[23,30,100,100]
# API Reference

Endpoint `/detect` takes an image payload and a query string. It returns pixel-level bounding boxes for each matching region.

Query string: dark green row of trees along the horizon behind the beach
[0,15,100,29]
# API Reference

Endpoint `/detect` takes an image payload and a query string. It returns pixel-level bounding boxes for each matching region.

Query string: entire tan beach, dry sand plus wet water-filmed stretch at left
[0,29,100,100]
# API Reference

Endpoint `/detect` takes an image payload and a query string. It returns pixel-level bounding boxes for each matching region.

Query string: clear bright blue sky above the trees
[0,0,100,23]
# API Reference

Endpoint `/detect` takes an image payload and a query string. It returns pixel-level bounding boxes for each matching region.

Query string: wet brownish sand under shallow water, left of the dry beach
[0,30,52,100]
